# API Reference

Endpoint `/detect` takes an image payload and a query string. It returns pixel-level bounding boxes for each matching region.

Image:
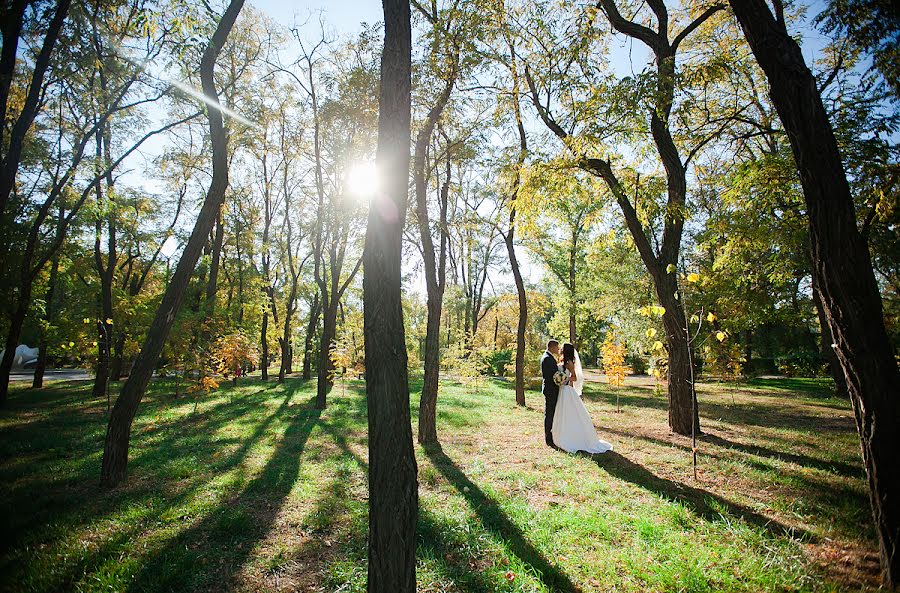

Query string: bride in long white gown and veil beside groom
[553,344,612,453]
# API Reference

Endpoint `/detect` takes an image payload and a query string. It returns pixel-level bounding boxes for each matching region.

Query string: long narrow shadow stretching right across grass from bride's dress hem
[592,451,816,542]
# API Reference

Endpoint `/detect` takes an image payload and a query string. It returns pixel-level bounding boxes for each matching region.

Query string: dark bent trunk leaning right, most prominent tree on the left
[100,0,244,487]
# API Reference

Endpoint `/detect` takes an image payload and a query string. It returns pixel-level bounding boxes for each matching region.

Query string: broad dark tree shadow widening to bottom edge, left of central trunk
[128,400,320,591]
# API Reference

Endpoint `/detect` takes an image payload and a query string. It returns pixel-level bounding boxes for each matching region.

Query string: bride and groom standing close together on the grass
[541,340,612,453]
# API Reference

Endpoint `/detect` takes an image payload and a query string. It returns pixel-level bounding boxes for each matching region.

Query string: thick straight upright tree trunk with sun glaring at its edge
[363,0,419,593]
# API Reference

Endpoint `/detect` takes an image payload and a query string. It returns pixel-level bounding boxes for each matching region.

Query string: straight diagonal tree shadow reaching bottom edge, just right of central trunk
[424,445,581,593]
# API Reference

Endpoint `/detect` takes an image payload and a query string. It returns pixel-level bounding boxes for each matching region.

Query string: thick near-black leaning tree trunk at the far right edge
[731,0,900,589]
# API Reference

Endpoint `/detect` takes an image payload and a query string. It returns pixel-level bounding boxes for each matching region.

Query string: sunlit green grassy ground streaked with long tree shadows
[0,372,877,592]
